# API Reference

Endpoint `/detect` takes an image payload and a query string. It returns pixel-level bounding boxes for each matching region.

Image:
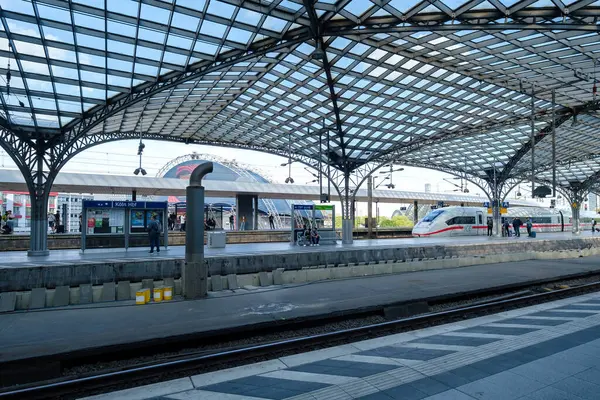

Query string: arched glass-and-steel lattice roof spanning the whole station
[0,0,600,193]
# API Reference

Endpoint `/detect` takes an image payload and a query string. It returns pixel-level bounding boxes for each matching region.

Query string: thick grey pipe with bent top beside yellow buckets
[181,162,213,299]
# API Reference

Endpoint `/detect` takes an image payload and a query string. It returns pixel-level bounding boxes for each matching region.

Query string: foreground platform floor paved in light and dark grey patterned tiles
[81,293,600,400]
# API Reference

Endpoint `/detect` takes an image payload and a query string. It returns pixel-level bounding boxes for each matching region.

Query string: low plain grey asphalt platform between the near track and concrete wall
[0,256,600,361]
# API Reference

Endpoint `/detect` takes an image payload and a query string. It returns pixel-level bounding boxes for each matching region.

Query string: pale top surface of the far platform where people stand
[0,232,600,268]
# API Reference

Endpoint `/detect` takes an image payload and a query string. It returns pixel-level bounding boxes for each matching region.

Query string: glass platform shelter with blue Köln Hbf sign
[81,200,169,252]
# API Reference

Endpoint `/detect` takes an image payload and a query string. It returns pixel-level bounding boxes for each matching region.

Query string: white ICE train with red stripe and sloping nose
[412,207,600,237]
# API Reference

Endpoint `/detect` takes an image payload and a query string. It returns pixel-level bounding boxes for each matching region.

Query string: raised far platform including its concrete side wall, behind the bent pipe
[0,232,600,292]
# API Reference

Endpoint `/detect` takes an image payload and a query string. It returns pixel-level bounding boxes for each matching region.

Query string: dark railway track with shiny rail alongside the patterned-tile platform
[0,275,600,400]
